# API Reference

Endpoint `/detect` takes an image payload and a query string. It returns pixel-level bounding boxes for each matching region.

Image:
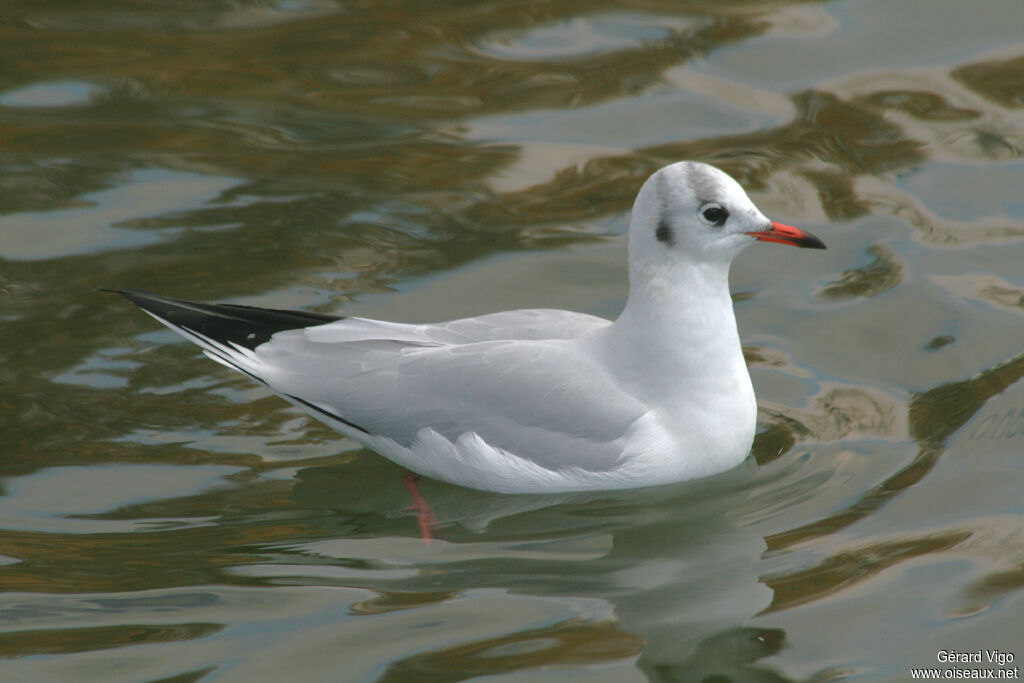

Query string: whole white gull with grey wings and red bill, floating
[112,162,824,493]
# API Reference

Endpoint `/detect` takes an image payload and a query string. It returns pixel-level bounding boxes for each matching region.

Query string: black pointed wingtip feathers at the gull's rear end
[100,288,341,349]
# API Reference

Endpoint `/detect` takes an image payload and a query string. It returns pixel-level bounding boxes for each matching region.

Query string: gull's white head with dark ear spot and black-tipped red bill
[630,162,825,268]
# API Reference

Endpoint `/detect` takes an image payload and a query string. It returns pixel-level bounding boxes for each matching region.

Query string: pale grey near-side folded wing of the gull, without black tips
[256,330,646,471]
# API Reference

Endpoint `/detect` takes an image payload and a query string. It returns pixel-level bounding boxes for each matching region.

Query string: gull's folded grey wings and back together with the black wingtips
[112,291,647,478]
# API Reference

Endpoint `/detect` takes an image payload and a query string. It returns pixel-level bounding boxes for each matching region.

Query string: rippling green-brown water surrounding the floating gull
[0,0,1024,683]
